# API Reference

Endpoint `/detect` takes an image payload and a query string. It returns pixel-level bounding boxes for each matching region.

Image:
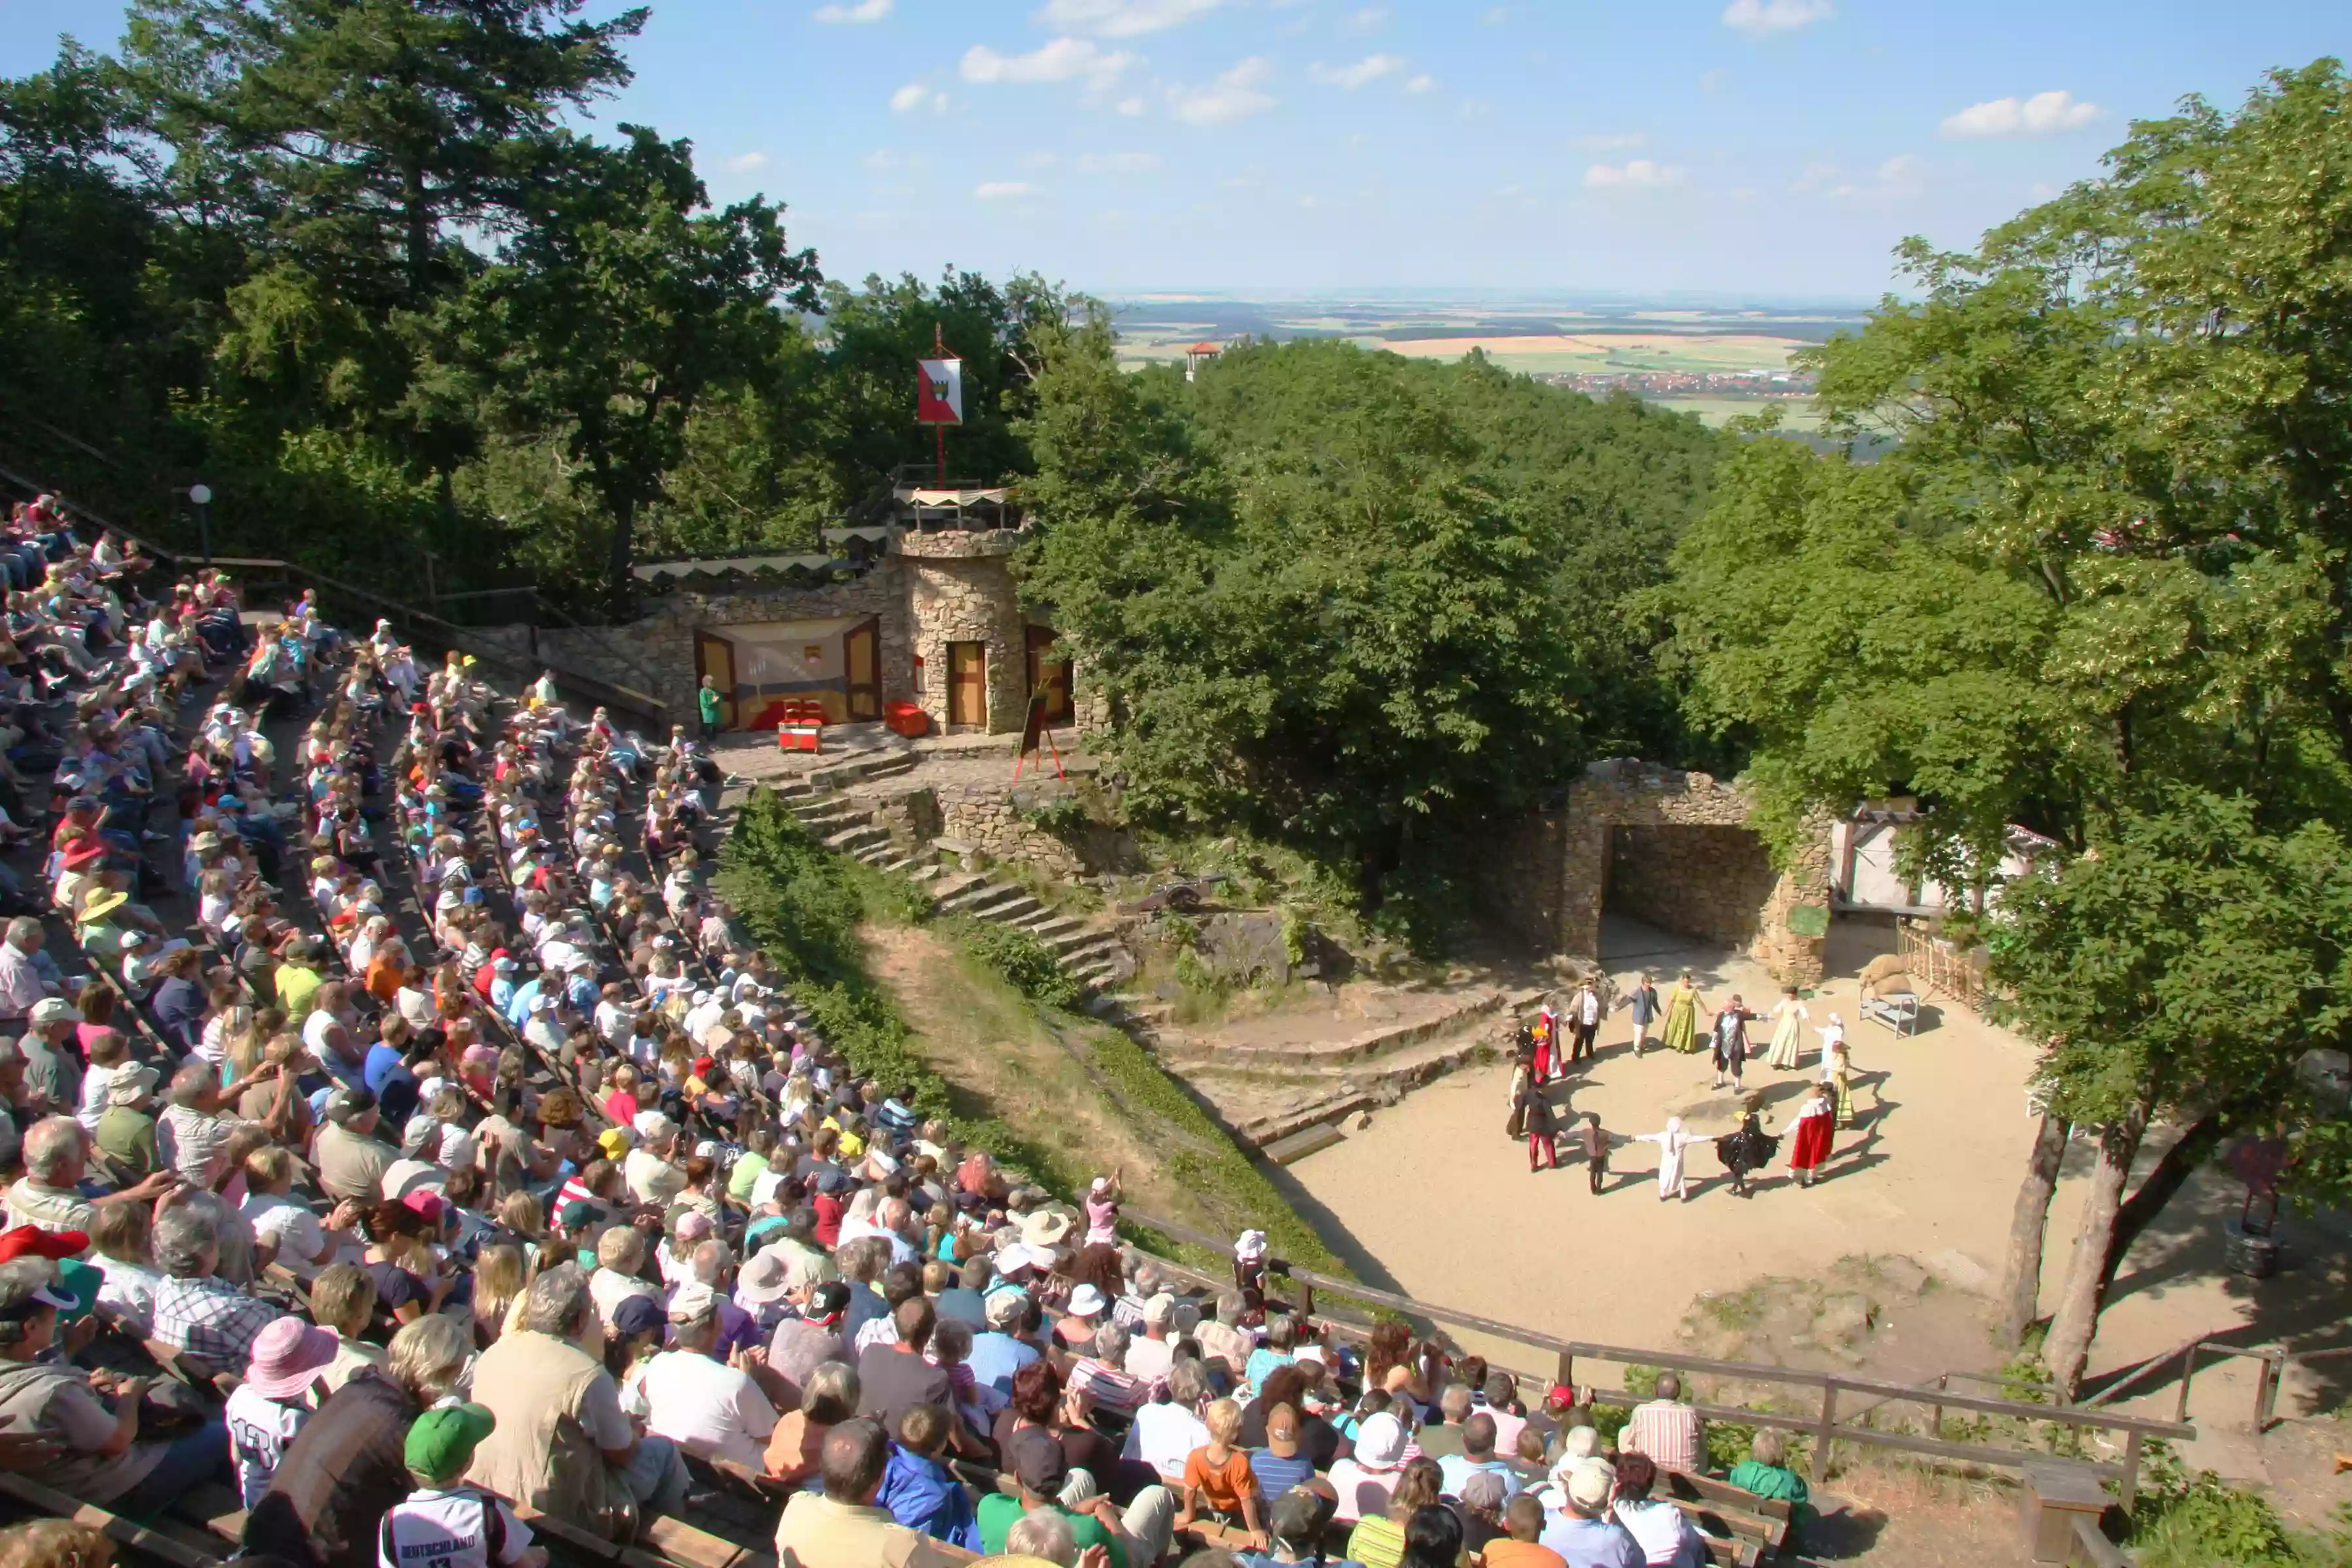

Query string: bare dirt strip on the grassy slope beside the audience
[861,926,1220,1230]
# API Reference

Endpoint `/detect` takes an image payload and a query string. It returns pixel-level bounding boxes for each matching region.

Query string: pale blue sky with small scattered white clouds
[0,0,2352,301]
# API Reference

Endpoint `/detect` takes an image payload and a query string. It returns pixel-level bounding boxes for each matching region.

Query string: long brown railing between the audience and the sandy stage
[1126,1208,2197,1509]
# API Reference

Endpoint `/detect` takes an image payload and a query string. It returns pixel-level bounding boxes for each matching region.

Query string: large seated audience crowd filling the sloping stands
[0,498,1804,1568]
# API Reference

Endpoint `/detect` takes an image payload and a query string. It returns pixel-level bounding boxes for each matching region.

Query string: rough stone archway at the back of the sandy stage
[1548,757,1830,985]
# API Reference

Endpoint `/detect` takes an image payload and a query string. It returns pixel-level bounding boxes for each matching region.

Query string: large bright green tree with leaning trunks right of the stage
[1661,61,2352,1387]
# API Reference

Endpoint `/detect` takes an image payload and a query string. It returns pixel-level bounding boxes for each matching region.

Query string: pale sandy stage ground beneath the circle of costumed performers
[1286,917,2352,1504]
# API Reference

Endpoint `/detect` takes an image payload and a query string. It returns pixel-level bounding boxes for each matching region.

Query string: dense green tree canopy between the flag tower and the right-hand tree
[1023,322,1717,919]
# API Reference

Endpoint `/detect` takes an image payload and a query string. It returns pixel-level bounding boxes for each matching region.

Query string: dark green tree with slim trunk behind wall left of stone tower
[453,127,819,616]
